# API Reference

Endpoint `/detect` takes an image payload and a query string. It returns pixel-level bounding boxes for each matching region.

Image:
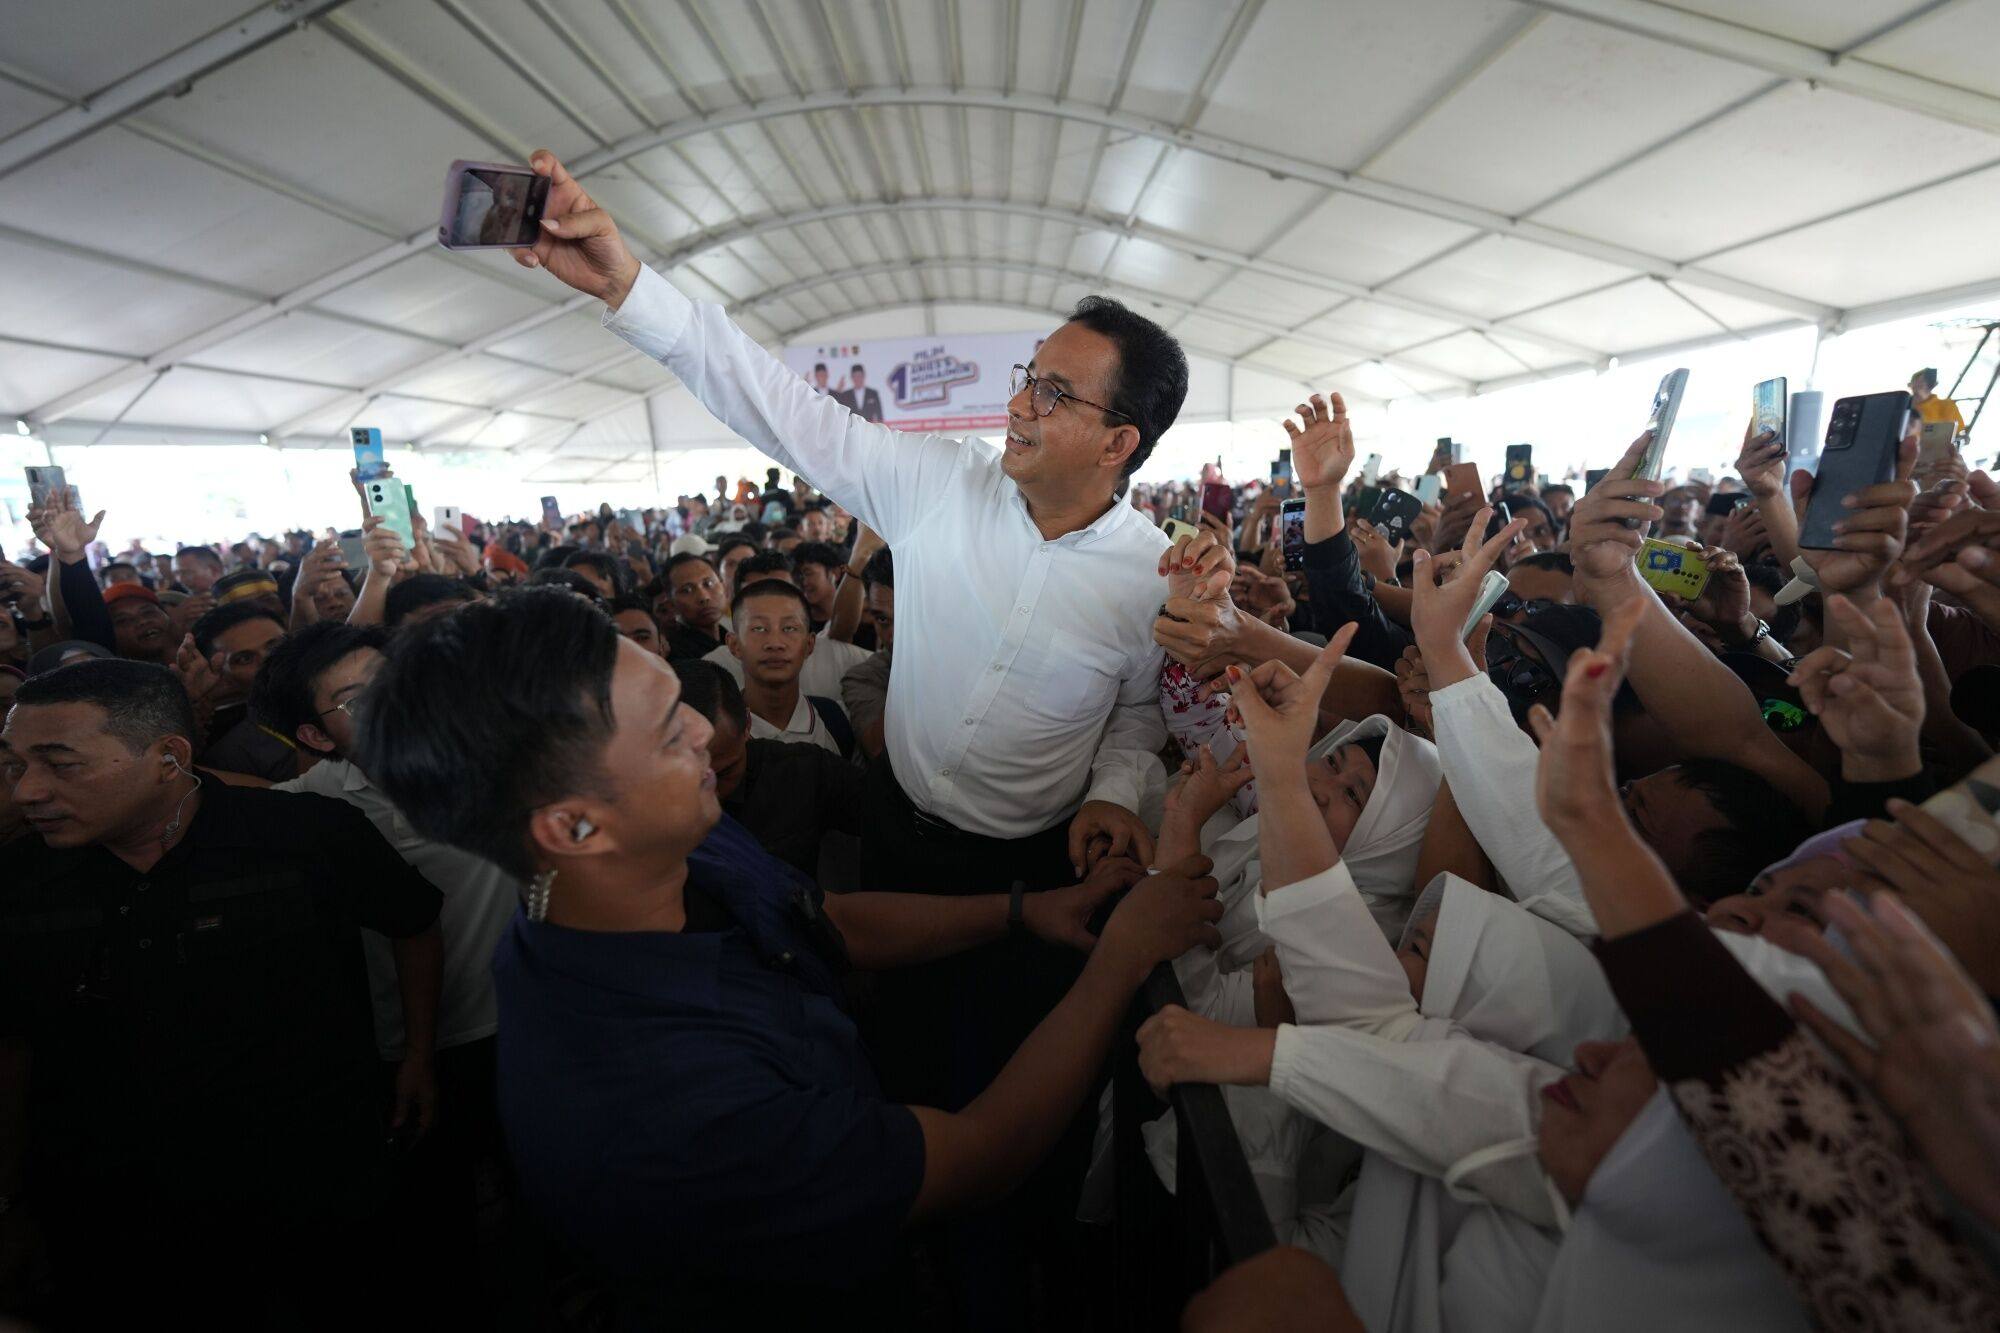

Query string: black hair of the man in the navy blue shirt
[356,588,618,879]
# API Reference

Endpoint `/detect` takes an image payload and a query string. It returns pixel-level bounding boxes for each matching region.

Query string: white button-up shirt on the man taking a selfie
[604,268,1168,839]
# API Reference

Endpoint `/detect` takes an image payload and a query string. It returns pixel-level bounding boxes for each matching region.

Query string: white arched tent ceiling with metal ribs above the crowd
[0,0,2000,480]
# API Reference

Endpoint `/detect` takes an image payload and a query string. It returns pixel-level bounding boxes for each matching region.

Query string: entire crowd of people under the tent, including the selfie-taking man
[0,145,2000,1333]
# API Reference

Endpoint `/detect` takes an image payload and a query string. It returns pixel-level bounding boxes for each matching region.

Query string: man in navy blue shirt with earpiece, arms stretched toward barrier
[360,590,1220,1315]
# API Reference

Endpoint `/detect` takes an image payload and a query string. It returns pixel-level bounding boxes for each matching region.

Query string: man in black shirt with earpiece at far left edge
[0,658,442,1329]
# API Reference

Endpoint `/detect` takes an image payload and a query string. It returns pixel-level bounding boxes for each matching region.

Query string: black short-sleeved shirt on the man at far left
[0,775,442,1217]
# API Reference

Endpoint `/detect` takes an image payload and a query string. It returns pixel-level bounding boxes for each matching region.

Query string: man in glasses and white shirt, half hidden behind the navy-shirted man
[250,620,520,1296]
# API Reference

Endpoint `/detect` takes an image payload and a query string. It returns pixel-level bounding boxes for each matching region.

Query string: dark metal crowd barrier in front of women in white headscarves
[1112,963,1278,1329]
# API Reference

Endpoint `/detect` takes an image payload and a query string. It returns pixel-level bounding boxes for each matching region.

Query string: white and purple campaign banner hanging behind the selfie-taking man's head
[784,332,1042,434]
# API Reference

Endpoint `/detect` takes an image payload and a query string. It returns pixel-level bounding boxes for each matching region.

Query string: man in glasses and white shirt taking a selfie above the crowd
[514,152,1188,891]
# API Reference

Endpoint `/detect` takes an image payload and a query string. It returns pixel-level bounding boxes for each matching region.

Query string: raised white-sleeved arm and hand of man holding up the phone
[514,150,964,544]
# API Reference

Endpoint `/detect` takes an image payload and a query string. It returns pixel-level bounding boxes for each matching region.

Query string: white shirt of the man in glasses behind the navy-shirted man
[278,759,520,1061]
